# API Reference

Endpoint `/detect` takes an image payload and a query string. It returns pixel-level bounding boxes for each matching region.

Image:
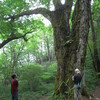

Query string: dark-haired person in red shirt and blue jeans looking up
[11,74,18,100]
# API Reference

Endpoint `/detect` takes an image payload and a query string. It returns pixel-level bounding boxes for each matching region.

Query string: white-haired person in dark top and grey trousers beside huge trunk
[72,68,82,100]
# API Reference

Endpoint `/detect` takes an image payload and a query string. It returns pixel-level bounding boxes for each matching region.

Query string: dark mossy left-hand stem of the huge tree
[51,1,72,100]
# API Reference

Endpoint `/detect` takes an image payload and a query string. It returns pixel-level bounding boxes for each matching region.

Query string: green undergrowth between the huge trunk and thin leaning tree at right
[85,49,99,90]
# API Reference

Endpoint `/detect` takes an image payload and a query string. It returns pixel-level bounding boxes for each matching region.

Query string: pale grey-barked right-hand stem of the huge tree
[74,0,90,95]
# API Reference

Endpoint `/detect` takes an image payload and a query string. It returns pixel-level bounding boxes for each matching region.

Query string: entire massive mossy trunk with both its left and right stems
[52,0,89,100]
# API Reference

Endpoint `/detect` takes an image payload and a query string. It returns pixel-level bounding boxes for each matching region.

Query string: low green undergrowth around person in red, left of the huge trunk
[0,62,56,100]
